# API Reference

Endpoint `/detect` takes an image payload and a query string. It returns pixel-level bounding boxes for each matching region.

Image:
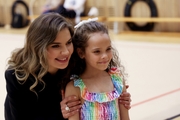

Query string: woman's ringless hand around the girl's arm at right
[119,85,131,110]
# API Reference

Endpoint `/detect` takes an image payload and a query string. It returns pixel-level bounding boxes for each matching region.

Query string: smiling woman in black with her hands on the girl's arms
[5,13,130,120]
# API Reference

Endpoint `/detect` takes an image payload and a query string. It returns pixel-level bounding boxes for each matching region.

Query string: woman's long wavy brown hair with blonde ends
[8,13,73,94]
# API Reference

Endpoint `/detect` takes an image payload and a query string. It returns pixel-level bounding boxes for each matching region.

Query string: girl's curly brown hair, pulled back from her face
[72,21,124,81]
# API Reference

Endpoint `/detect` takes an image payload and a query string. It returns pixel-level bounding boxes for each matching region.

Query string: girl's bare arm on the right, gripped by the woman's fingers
[119,82,130,120]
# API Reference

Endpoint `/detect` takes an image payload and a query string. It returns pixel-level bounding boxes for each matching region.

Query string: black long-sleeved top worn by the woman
[4,70,64,120]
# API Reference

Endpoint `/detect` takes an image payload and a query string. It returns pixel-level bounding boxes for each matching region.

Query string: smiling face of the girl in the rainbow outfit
[83,32,112,70]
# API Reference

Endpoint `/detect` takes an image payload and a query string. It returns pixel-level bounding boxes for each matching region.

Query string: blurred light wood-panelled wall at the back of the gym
[0,0,180,32]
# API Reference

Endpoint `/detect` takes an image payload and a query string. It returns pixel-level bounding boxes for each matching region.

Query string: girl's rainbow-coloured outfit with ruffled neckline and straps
[72,68,123,120]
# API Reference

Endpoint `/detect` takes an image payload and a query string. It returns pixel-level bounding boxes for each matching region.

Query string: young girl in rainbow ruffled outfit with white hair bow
[65,19,129,120]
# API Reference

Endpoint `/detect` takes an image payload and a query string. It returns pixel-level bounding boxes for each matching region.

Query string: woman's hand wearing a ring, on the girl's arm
[60,91,81,118]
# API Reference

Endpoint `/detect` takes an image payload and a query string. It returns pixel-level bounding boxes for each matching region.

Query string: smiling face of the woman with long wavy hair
[47,28,74,74]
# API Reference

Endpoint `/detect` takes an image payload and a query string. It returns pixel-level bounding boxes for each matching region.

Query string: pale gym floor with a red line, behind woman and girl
[0,26,180,120]
